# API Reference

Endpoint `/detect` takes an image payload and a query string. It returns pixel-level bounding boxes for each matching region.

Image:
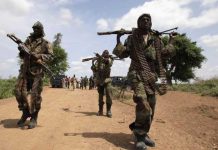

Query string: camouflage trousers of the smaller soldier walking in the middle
[97,82,112,106]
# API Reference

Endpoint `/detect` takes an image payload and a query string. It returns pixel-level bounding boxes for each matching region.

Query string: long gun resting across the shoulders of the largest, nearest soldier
[97,27,178,35]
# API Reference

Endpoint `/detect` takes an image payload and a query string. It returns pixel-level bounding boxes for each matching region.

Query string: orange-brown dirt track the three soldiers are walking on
[0,88,218,150]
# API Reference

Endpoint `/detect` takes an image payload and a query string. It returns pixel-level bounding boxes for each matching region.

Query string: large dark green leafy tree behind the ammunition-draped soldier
[163,34,206,85]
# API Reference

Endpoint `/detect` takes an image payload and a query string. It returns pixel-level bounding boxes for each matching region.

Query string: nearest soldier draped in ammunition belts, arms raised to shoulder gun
[113,14,174,150]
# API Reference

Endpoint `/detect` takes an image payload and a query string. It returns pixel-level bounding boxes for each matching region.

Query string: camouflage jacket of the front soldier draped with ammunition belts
[113,30,174,94]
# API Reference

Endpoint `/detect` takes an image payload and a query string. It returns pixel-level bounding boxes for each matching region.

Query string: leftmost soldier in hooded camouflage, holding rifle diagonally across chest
[15,21,53,129]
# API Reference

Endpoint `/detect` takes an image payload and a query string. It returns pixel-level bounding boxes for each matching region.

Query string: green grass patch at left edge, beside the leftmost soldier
[0,77,16,99]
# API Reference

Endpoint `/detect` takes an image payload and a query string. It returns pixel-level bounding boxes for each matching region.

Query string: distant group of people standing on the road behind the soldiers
[62,75,96,90]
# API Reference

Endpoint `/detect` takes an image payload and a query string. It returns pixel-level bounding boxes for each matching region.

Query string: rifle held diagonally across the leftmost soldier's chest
[7,34,54,78]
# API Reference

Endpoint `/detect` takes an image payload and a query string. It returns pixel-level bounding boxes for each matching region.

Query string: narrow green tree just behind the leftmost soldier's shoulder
[49,33,70,74]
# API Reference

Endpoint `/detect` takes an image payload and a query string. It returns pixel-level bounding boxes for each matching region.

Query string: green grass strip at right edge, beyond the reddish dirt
[169,78,218,97]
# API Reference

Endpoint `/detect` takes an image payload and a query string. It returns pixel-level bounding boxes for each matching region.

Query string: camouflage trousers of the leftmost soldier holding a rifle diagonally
[15,74,43,114]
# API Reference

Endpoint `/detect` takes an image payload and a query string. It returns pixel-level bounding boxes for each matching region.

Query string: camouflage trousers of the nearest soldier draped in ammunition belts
[129,70,156,135]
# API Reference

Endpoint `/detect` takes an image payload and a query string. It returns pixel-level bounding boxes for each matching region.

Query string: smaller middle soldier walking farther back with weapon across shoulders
[91,50,113,118]
